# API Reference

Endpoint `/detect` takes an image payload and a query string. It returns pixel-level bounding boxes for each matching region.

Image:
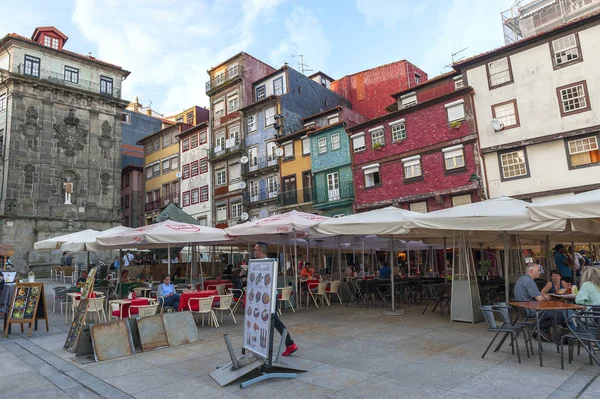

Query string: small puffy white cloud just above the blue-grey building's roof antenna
[271,7,331,75]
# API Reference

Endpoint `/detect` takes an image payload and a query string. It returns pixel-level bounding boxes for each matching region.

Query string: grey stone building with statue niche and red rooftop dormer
[0,27,129,270]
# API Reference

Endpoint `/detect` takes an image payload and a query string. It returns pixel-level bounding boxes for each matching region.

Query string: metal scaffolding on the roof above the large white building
[501,0,600,44]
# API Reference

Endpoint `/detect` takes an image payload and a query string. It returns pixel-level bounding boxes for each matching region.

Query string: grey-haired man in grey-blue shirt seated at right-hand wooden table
[515,263,565,341]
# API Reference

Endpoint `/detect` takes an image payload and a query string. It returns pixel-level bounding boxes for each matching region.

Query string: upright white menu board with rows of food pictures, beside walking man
[243,259,277,359]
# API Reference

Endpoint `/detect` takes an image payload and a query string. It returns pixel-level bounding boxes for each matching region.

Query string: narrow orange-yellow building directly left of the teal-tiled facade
[277,127,317,213]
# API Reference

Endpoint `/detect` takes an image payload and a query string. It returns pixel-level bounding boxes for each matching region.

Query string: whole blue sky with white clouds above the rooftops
[0,0,514,115]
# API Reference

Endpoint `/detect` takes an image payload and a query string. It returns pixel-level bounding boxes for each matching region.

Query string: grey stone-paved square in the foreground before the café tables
[0,281,600,399]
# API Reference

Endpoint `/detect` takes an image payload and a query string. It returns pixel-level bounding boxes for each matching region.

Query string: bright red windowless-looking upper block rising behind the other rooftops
[329,60,427,119]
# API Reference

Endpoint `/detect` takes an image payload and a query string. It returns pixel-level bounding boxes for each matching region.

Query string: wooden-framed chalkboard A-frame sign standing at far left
[4,283,50,337]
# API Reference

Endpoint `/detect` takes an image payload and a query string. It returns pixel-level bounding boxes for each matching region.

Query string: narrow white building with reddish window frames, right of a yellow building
[178,121,212,226]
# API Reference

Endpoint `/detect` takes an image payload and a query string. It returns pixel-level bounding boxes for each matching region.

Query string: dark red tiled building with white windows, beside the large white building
[348,72,483,212]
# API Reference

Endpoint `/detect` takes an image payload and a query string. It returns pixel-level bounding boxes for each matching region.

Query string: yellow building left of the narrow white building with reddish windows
[137,123,189,224]
